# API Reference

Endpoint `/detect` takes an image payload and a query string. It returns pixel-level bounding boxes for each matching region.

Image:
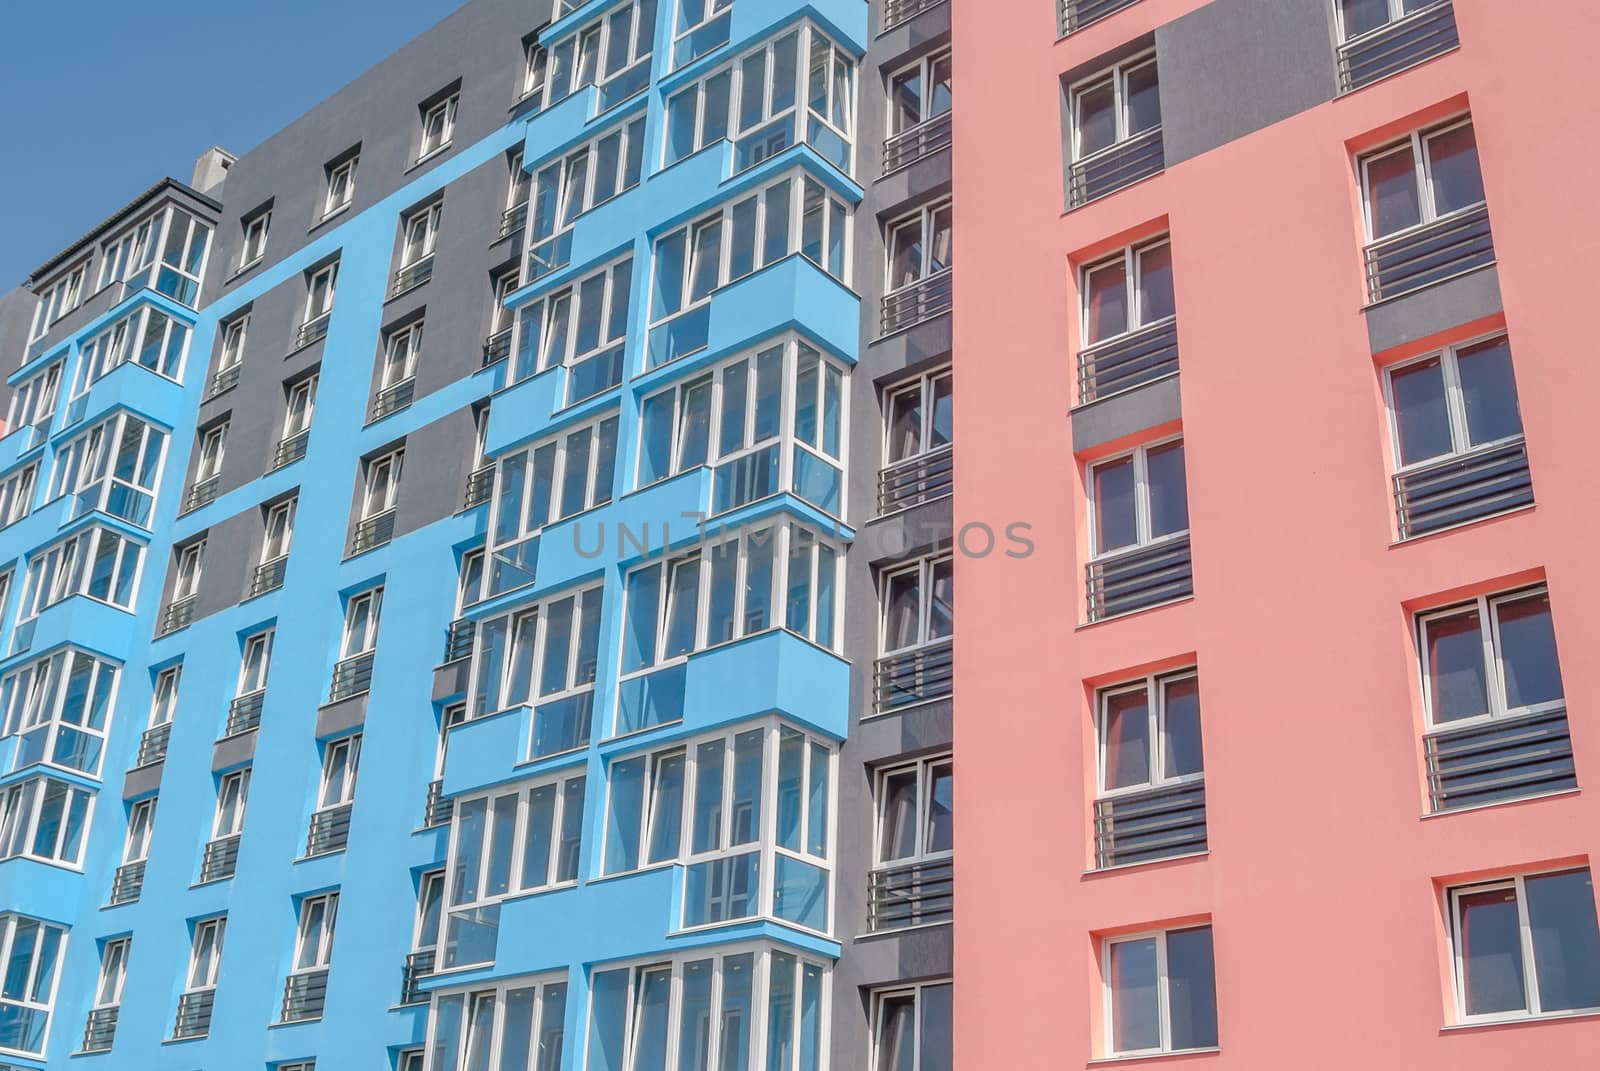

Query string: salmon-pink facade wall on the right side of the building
[954,0,1600,1071]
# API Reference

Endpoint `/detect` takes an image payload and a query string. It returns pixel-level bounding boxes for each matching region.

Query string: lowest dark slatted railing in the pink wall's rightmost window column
[1426,711,1578,812]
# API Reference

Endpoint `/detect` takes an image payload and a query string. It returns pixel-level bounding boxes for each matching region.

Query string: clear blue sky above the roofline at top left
[0,0,464,293]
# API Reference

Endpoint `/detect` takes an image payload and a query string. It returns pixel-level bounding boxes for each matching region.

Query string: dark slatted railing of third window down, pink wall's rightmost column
[1394,439,1533,540]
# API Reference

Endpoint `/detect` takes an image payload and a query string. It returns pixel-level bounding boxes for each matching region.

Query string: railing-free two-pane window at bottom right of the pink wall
[1448,869,1600,1023]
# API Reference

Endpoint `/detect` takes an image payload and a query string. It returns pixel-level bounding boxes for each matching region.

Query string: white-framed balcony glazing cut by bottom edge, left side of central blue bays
[425,977,569,1071]
